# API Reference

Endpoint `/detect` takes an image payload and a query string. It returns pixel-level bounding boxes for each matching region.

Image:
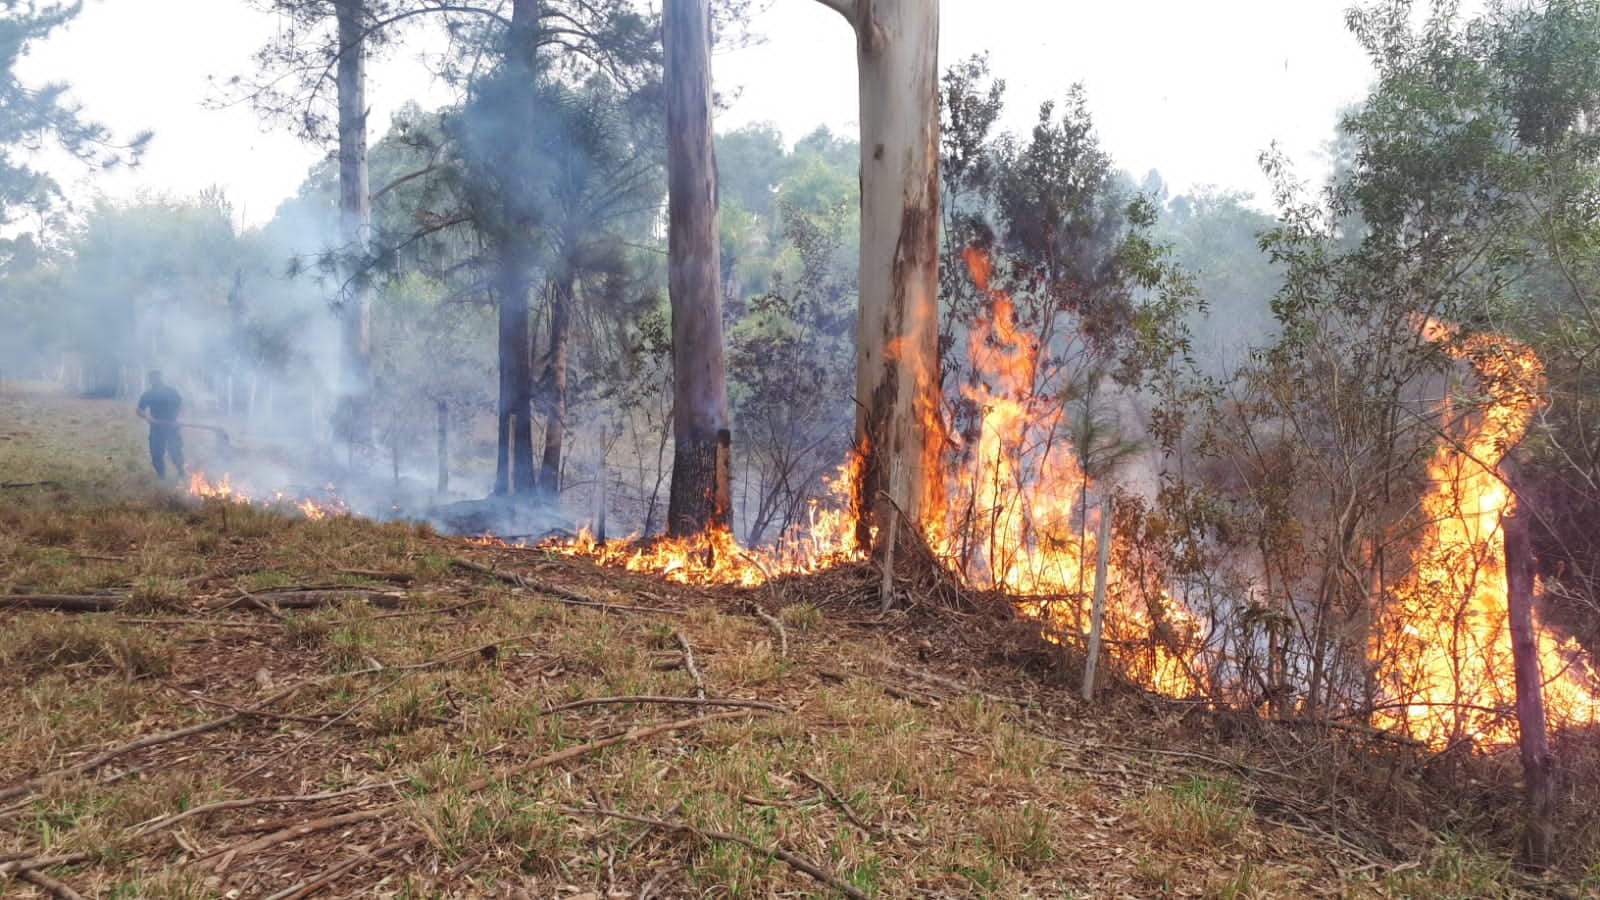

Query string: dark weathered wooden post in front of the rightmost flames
[1501,516,1555,870]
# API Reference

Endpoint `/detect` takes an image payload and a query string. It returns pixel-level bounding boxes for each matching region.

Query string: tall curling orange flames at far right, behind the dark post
[1373,320,1600,746]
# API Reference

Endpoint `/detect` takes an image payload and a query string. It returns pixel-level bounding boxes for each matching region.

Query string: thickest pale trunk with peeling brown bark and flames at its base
[819,0,944,552]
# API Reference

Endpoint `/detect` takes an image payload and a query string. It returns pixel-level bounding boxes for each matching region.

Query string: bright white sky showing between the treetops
[22,0,1370,224]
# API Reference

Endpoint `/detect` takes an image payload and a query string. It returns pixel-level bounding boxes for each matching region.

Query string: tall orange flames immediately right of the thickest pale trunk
[926,247,1200,695]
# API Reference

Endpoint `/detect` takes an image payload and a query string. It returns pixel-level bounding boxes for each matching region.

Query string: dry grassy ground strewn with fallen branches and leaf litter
[0,388,1600,900]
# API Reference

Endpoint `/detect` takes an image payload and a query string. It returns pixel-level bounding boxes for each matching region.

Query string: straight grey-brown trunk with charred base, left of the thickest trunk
[661,0,731,536]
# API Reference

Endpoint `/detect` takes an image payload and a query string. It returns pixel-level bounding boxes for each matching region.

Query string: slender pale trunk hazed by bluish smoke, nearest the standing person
[334,0,373,445]
